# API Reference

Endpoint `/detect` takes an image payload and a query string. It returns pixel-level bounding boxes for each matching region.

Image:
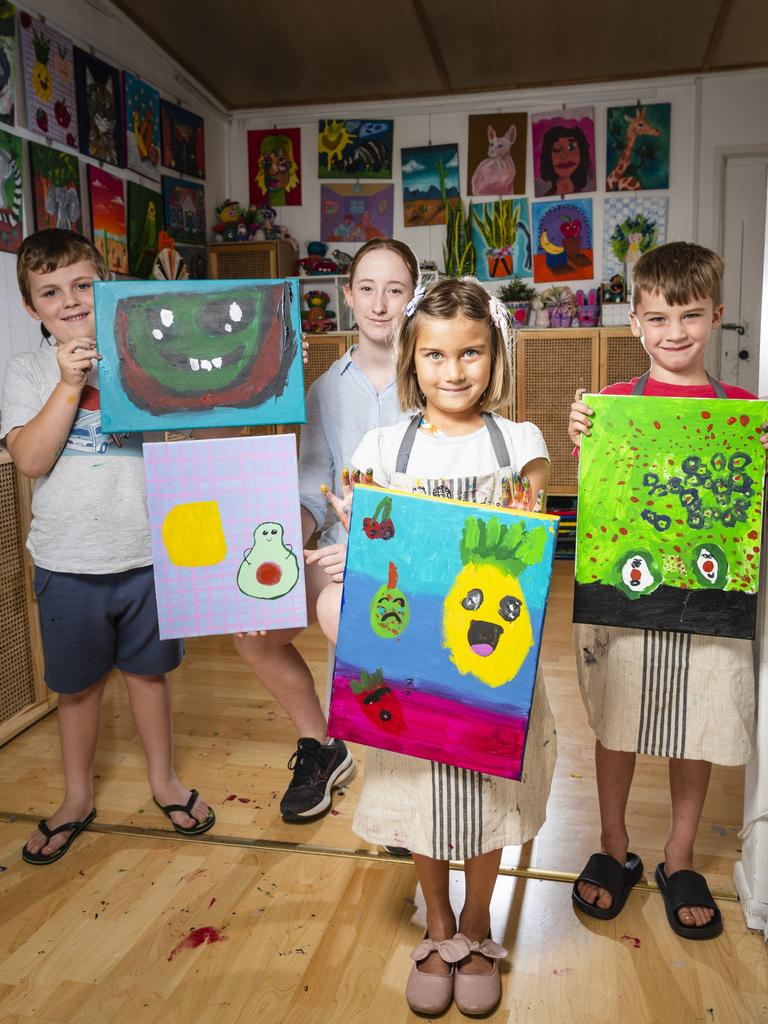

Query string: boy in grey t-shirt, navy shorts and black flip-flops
[0,228,215,864]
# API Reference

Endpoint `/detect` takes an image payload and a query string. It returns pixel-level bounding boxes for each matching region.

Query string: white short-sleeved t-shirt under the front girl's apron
[352,415,549,501]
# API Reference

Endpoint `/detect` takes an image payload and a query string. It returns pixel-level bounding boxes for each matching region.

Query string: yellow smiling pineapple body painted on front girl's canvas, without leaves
[442,562,534,686]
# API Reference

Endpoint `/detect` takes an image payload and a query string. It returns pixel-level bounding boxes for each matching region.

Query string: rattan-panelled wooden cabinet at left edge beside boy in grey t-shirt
[0,452,55,744]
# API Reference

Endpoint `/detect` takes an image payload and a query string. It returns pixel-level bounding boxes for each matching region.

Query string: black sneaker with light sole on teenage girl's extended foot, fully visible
[280,739,354,821]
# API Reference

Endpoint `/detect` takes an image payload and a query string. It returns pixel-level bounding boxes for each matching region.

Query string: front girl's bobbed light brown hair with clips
[395,278,512,413]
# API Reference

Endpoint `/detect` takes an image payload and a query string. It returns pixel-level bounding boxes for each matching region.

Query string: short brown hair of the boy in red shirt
[632,242,725,309]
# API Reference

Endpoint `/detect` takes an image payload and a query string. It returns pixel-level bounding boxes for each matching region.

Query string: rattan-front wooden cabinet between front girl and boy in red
[515,327,648,495]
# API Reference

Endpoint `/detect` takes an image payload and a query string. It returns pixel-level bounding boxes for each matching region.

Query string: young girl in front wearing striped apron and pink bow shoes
[321,279,556,1014]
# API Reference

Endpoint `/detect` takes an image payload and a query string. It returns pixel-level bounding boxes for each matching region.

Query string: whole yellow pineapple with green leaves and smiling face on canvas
[442,516,546,687]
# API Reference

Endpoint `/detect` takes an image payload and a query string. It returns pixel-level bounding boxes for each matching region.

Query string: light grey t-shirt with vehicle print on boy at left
[0,346,152,574]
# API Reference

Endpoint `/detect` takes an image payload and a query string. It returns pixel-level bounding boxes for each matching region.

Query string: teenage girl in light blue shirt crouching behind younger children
[234,238,419,821]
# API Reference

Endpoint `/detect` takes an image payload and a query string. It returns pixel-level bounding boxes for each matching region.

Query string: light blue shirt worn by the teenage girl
[299,345,410,544]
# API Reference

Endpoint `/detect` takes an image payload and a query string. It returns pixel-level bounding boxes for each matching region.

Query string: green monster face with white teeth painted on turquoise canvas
[115,282,297,415]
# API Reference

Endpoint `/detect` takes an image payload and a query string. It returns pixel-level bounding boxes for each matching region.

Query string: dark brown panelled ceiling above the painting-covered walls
[116,0,768,111]
